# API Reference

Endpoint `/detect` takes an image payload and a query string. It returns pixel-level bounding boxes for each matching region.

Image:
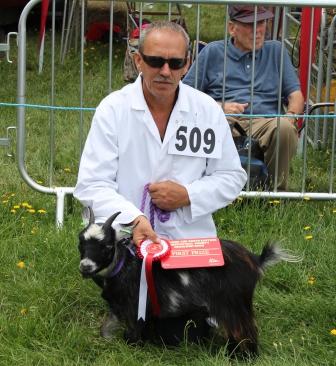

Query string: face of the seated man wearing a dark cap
[229,20,266,51]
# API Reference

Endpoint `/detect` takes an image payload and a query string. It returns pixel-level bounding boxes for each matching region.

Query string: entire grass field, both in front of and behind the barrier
[0,3,336,366]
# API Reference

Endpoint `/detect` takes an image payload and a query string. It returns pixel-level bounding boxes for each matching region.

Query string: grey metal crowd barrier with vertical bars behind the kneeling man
[9,0,336,225]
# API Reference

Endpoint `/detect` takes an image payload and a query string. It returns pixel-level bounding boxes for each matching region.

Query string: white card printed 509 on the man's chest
[168,124,224,159]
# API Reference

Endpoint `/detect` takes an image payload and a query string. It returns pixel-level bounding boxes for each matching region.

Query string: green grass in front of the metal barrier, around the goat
[0,192,336,365]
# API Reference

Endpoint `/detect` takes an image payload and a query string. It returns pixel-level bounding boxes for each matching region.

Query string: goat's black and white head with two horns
[78,207,120,277]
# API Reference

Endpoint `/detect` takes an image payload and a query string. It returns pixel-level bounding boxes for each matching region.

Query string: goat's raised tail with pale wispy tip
[259,243,303,270]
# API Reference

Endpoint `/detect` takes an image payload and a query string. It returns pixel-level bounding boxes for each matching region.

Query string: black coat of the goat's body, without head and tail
[102,241,261,353]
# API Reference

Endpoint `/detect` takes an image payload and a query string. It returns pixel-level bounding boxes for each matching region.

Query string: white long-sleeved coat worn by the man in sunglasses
[74,76,246,239]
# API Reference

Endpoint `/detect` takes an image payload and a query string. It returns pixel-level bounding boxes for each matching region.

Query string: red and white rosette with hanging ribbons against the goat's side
[138,239,170,320]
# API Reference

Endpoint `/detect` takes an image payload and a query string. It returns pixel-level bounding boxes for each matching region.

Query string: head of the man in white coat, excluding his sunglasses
[135,29,189,102]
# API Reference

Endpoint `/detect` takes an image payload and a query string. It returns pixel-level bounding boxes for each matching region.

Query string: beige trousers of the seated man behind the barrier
[228,117,298,191]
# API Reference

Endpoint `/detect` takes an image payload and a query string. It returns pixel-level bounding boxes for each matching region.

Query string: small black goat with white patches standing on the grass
[79,210,298,355]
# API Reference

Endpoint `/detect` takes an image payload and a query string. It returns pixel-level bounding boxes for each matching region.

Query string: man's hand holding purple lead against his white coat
[148,180,190,211]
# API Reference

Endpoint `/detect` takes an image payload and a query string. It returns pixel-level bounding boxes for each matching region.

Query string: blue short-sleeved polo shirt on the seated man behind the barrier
[183,40,300,114]
